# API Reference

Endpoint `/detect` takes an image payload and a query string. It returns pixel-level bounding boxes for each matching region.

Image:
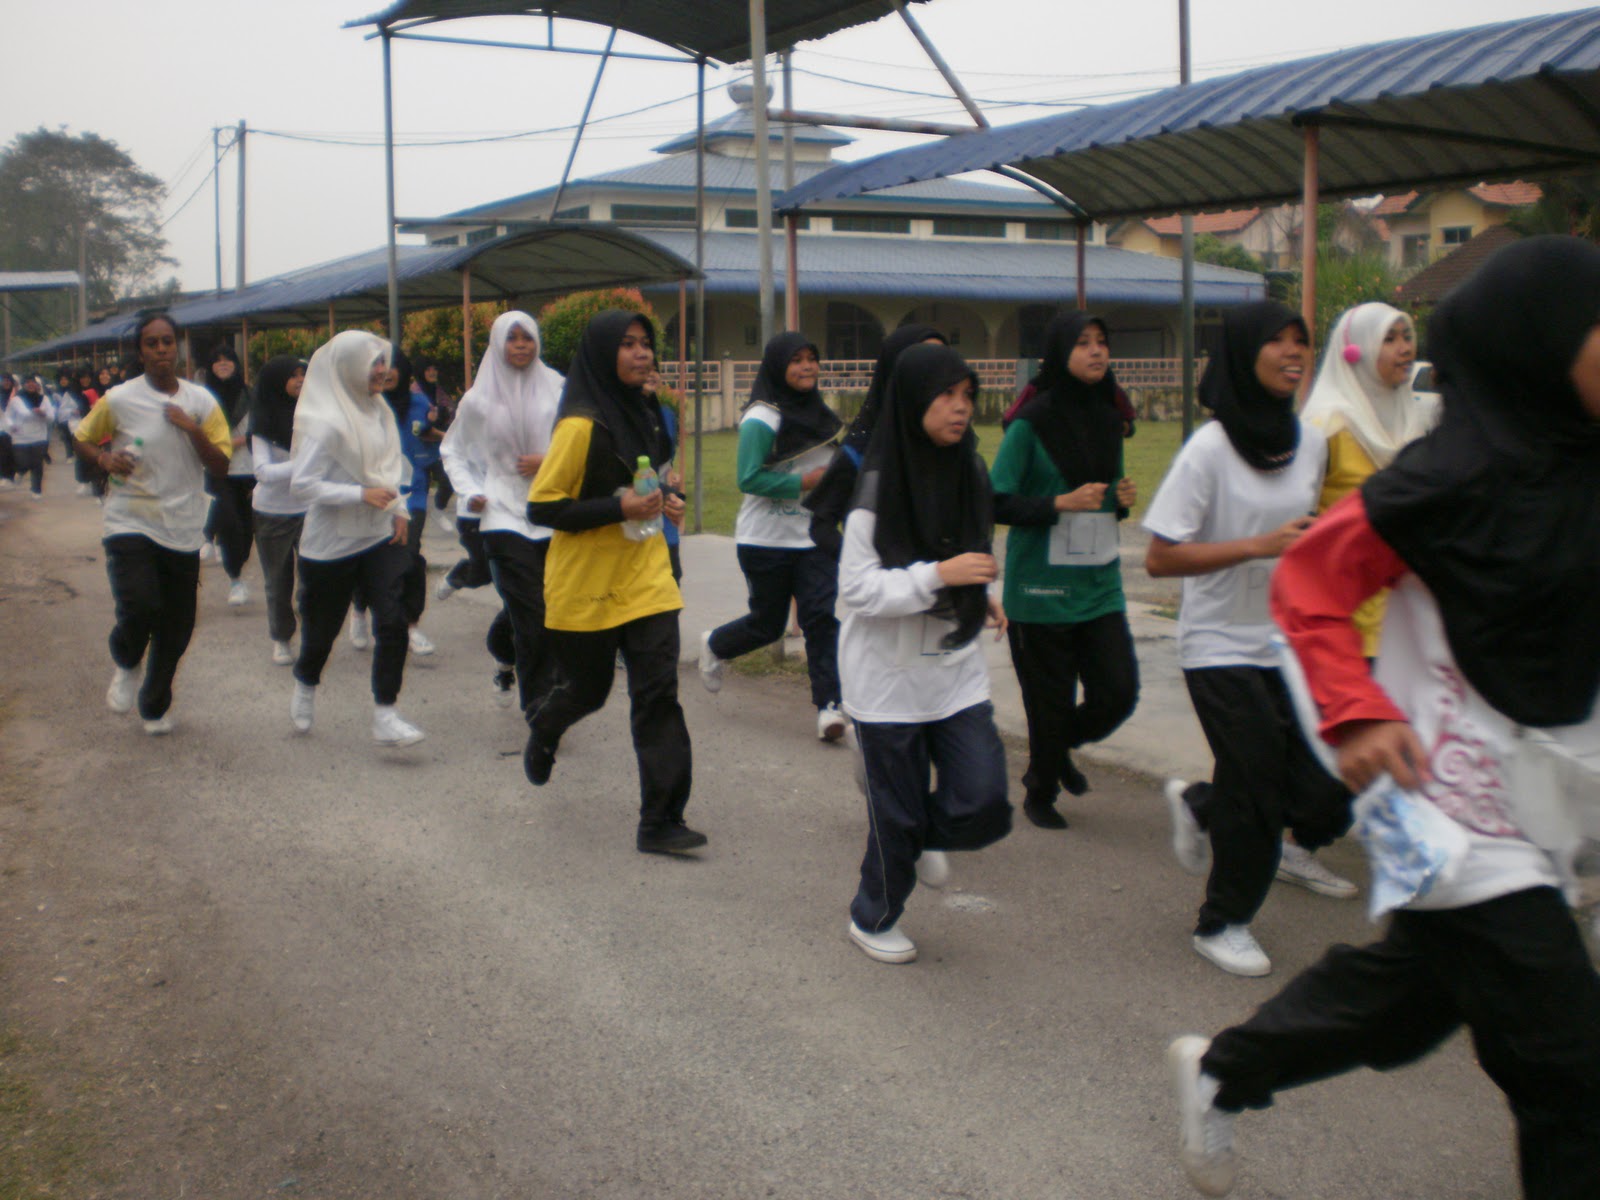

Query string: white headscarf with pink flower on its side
[1301,302,1435,470]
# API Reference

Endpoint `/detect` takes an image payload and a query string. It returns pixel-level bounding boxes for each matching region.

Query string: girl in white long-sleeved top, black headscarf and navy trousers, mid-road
[838,346,1011,963]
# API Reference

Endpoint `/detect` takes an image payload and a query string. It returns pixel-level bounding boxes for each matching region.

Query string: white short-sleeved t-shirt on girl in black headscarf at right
[1144,421,1328,670]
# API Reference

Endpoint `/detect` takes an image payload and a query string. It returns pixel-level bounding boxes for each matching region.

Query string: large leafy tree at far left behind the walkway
[0,128,174,333]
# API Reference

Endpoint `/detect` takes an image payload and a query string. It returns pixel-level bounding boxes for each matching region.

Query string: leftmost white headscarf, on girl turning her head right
[291,330,405,509]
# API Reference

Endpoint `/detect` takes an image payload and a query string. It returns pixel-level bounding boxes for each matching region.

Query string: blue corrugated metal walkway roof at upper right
[776,8,1600,219]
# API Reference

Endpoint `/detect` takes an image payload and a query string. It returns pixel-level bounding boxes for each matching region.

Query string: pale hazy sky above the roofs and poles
[0,0,1578,288]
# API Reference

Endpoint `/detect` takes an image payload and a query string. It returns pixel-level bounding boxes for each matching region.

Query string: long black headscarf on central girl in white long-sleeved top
[853,346,995,650]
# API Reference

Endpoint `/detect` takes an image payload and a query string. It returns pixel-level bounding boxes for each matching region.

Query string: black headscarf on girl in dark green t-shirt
[1014,312,1122,491]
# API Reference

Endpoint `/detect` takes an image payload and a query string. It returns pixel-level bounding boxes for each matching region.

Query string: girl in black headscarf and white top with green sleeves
[699,333,845,741]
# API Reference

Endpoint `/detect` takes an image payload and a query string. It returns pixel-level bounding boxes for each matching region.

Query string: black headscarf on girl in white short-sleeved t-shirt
[1200,301,1306,470]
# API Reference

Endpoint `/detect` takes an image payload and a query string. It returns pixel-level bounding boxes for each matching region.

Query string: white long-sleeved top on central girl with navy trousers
[838,509,989,723]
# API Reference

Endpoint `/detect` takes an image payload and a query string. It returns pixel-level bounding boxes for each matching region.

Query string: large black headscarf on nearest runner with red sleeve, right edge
[1362,237,1600,726]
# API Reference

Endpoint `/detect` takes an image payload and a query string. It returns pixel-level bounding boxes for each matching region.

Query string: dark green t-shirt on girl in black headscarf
[990,421,1126,626]
